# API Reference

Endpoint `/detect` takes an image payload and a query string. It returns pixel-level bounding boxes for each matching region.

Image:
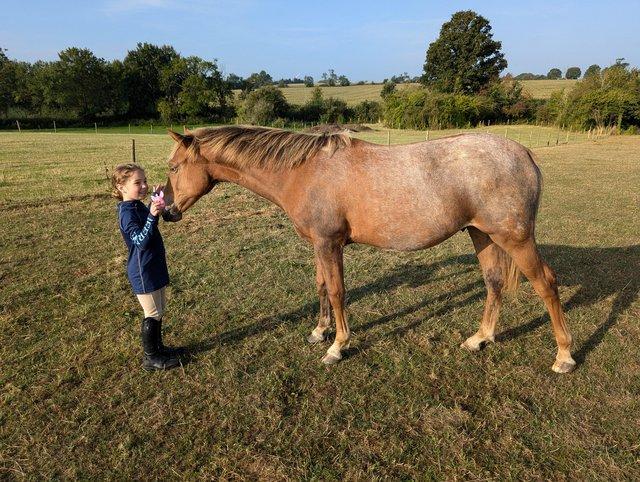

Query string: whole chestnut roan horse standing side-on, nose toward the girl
[165,126,575,373]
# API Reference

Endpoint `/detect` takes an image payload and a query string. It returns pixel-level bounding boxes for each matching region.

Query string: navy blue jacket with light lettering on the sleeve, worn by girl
[118,201,169,294]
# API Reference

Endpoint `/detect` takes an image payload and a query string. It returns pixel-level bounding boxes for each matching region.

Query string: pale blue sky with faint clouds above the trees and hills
[0,0,640,81]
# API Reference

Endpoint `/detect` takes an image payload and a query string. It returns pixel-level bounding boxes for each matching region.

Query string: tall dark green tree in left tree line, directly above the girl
[123,43,178,118]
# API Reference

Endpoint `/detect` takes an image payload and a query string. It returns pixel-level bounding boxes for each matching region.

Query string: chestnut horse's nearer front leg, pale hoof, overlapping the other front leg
[314,240,351,365]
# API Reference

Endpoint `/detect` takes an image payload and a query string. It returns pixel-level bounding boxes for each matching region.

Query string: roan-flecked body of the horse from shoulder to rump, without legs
[292,134,539,250]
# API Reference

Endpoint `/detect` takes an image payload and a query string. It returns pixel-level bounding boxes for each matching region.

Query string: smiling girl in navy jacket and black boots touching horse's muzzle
[111,164,182,370]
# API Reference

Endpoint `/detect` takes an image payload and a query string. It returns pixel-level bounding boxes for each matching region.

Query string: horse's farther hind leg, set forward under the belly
[461,226,505,351]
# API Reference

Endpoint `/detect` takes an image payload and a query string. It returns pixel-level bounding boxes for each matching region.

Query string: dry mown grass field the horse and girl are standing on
[0,126,640,480]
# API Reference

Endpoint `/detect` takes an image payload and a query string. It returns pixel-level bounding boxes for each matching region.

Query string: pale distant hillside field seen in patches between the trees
[231,79,576,105]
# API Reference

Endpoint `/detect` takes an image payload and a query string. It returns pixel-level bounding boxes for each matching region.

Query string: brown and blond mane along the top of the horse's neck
[189,126,351,171]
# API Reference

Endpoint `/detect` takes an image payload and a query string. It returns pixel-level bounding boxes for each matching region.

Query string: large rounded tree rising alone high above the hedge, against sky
[422,10,507,93]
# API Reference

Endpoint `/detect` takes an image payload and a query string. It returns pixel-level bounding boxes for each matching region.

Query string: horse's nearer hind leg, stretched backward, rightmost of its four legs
[494,237,576,373]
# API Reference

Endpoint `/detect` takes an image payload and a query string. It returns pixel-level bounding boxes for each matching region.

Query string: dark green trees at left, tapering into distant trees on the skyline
[0,43,360,124]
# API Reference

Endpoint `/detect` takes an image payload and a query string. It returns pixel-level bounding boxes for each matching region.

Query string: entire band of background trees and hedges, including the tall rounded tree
[0,10,640,129]
